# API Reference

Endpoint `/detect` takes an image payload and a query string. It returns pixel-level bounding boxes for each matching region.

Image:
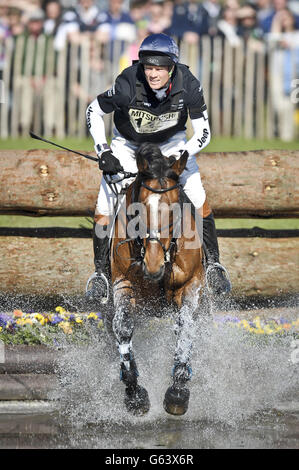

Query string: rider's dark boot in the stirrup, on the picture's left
[85,224,110,304]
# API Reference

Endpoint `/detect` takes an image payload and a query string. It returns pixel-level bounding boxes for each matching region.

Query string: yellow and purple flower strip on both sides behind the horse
[0,307,299,345]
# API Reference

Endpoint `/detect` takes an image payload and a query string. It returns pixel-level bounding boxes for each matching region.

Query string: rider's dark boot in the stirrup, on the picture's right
[202,213,231,295]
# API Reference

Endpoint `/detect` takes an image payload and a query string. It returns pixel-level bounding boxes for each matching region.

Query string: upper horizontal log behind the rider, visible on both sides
[0,150,299,217]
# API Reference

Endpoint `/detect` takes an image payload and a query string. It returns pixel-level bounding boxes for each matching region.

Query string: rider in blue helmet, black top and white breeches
[86,34,231,301]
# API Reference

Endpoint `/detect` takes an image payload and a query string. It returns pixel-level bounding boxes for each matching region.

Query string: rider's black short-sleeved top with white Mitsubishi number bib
[97,63,207,144]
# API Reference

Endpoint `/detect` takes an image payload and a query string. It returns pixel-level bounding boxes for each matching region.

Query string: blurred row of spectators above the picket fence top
[0,0,299,52]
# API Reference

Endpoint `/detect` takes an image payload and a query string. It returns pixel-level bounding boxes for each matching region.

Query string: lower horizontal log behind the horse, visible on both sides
[0,236,299,298]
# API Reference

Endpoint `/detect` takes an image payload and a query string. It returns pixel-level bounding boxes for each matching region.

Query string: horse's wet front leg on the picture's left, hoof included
[112,280,150,415]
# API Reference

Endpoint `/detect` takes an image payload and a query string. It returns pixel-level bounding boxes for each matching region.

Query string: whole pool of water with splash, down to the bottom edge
[0,299,299,449]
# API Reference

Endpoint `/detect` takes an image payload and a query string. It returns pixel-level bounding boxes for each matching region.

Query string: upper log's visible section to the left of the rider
[0,150,101,215]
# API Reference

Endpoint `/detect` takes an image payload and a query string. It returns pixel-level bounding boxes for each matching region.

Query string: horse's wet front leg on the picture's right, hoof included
[163,282,199,415]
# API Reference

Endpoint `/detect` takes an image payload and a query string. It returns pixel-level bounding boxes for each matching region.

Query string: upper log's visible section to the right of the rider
[198,150,299,217]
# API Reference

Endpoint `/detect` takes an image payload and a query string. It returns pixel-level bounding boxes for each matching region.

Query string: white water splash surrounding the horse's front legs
[51,308,298,440]
